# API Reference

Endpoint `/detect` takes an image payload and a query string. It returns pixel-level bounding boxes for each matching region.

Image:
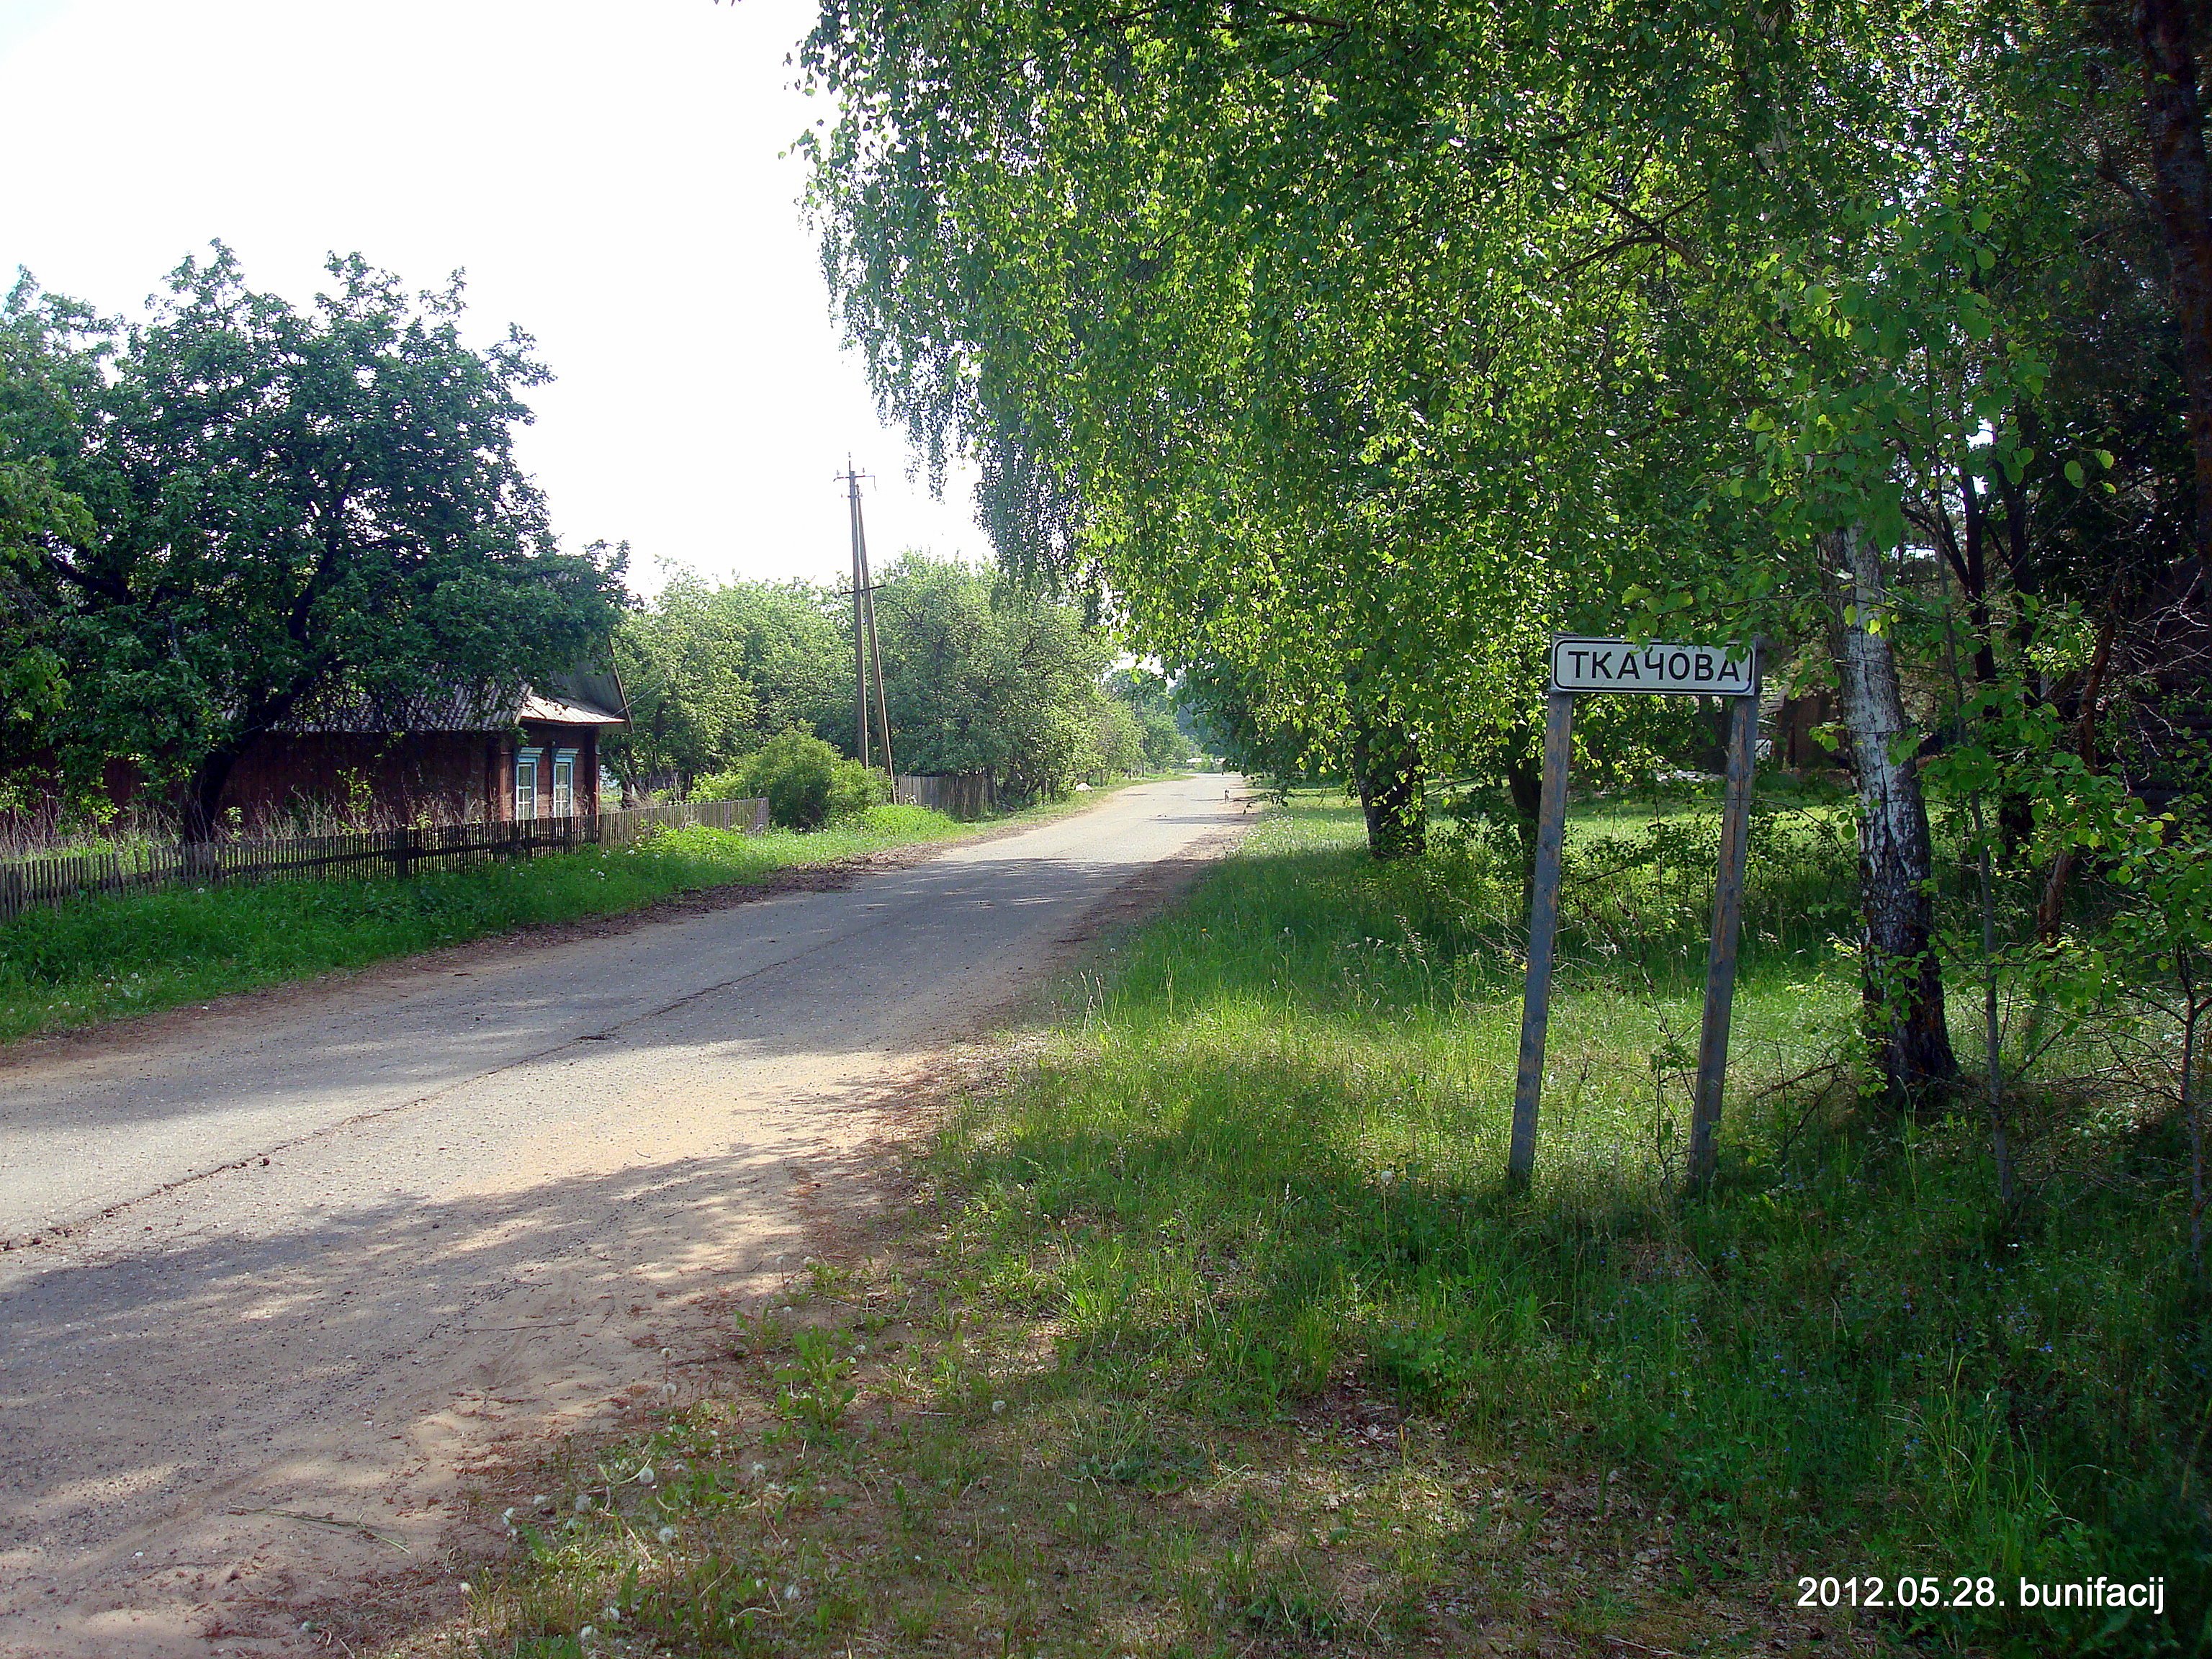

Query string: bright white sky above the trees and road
[0,0,986,588]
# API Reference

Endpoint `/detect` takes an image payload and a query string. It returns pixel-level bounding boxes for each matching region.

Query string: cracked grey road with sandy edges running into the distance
[0,778,1246,1659]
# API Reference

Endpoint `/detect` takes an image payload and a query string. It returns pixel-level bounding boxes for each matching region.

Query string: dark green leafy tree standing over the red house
[9,246,621,834]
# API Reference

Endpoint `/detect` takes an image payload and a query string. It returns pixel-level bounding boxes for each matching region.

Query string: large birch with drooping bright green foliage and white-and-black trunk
[809,0,2203,1090]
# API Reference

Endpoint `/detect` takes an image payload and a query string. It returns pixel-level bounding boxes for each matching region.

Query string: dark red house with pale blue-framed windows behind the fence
[221,673,628,827]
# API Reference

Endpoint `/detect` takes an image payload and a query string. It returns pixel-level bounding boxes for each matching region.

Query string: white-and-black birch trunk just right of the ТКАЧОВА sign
[1820,526,1958,1102]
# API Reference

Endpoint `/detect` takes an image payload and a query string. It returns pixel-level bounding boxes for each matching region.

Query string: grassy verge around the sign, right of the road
[393,796,2212,1659]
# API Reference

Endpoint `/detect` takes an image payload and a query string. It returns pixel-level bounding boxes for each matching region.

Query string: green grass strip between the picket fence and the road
[0,805,989,1042]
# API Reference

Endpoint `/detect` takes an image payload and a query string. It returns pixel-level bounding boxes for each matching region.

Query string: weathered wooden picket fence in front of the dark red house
[0,801,768,918]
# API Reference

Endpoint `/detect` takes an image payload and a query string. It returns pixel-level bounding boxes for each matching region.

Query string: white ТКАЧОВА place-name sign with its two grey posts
[1506,639,1758,1188]
